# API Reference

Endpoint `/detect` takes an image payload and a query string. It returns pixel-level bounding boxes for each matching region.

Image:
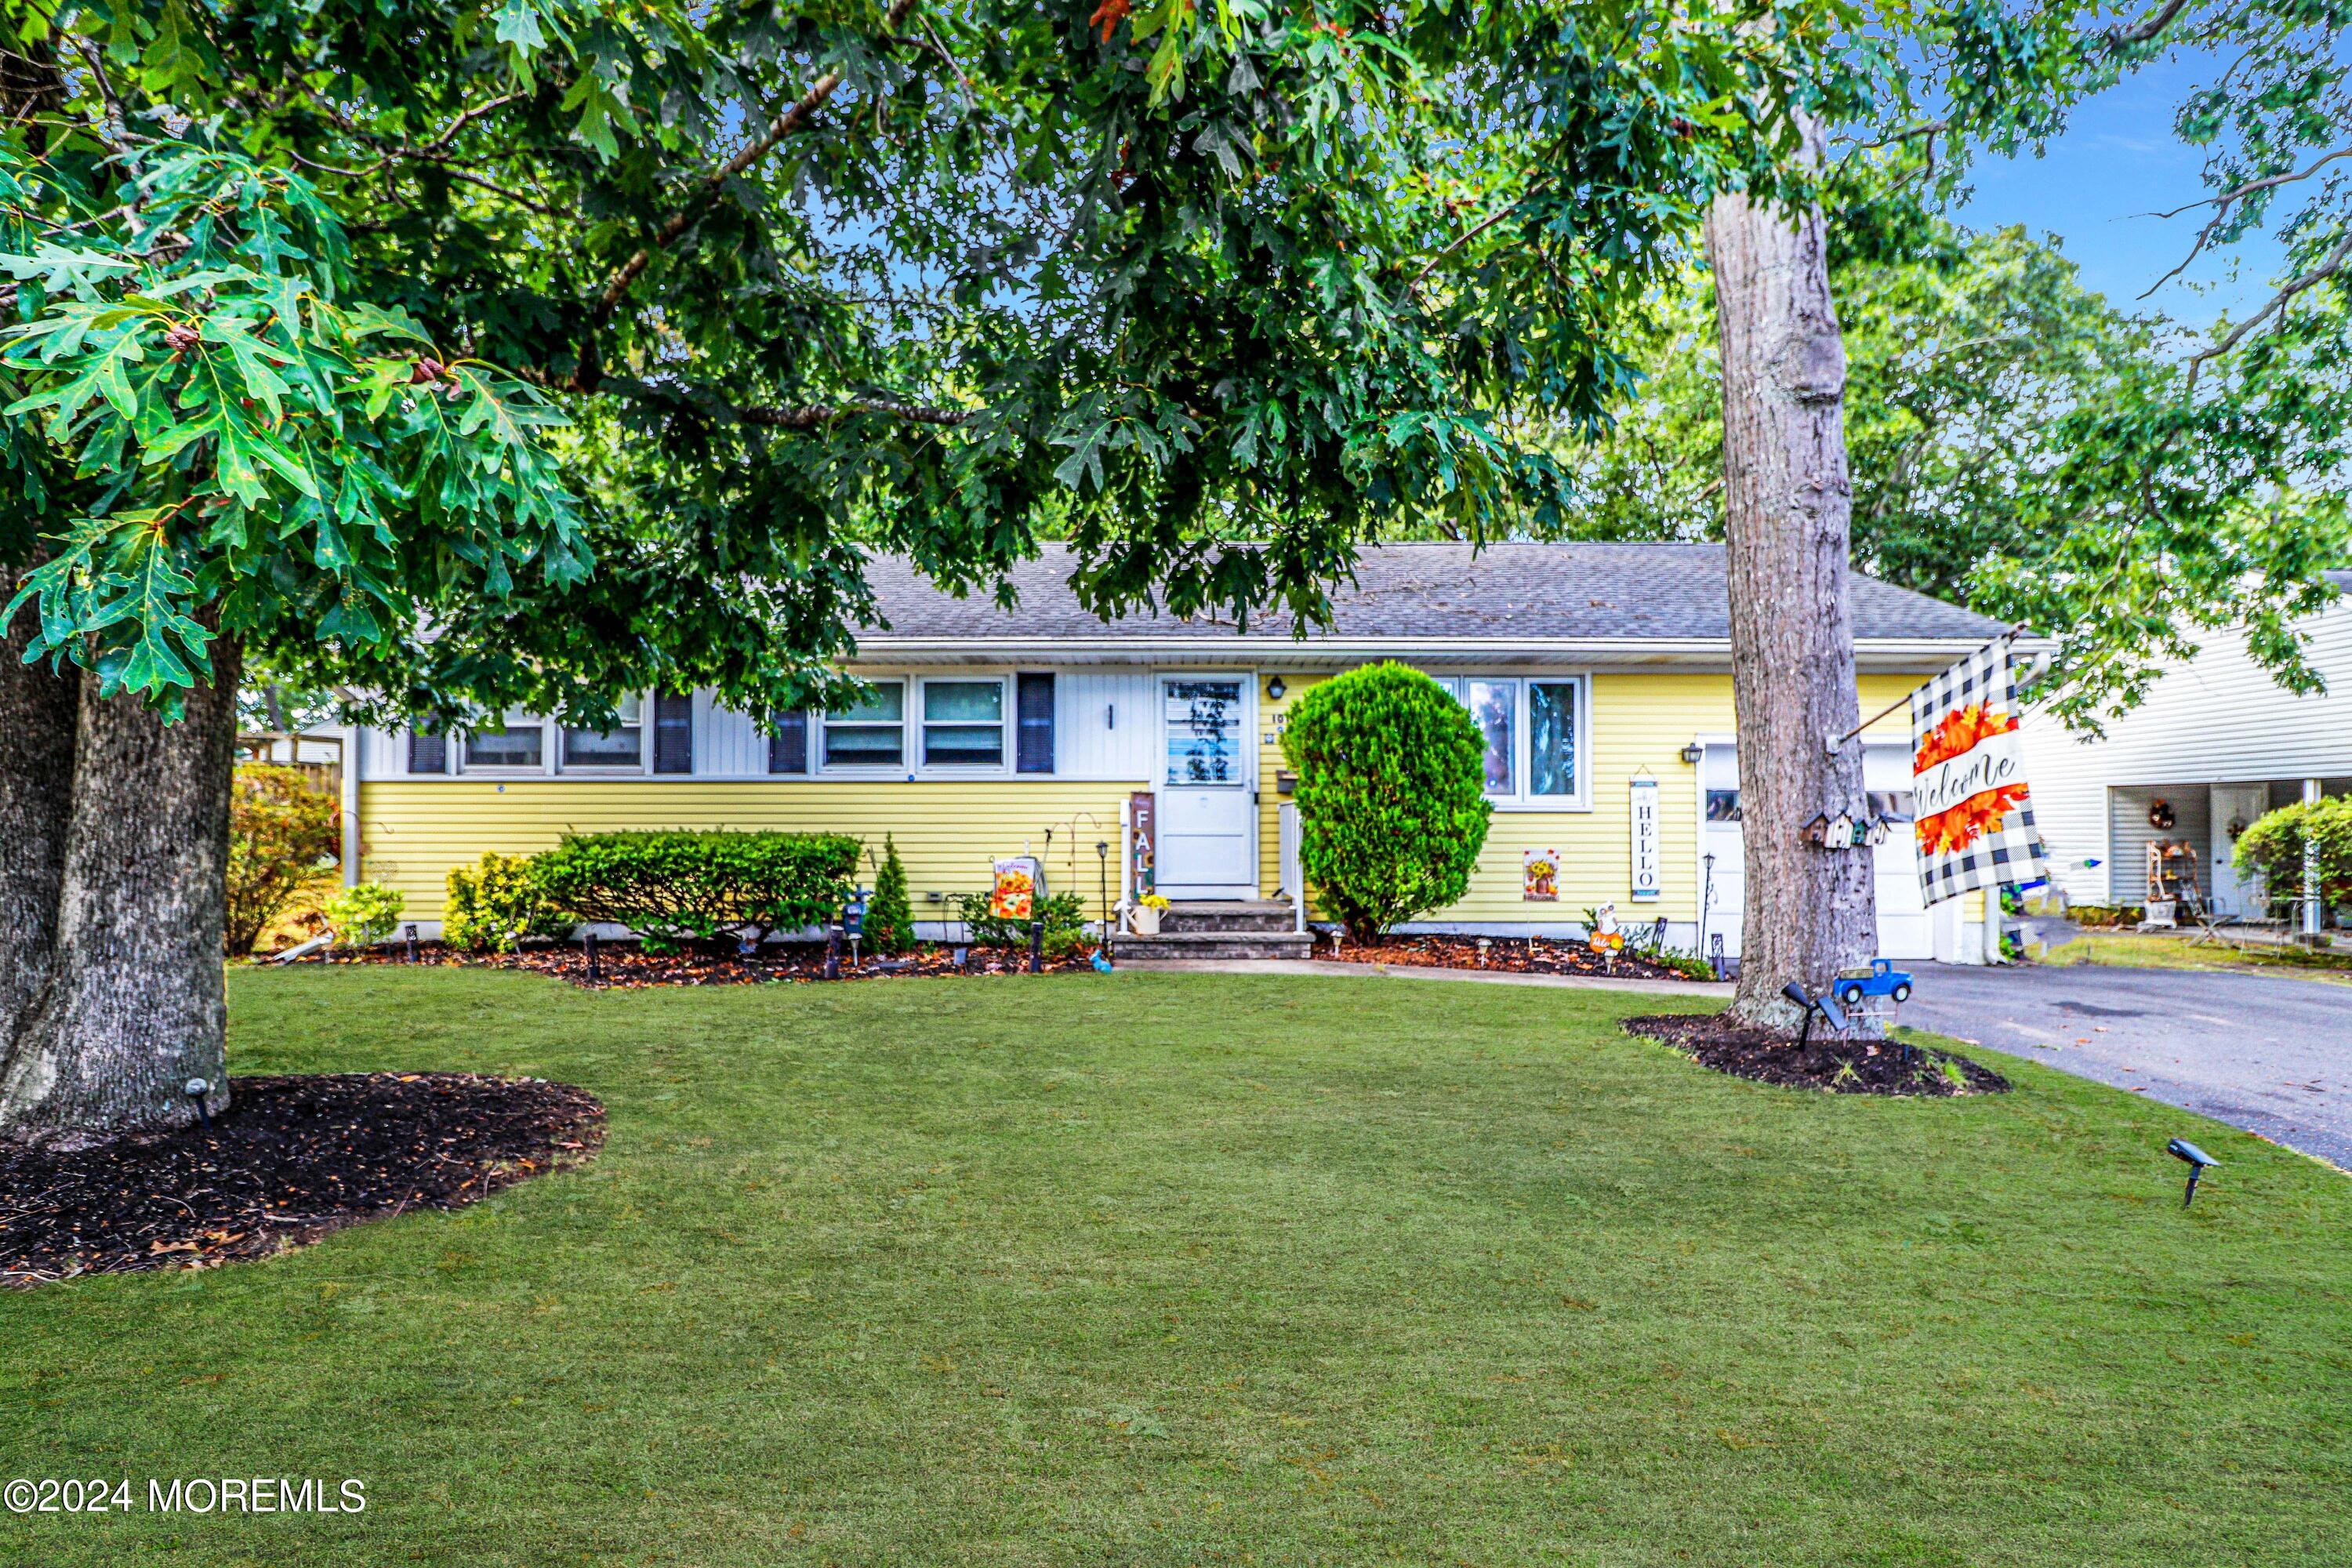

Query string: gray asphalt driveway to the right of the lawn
[1900,964,2352,1171]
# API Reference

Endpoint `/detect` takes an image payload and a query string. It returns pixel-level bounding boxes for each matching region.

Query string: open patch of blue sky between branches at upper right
[1955,56,2279,327]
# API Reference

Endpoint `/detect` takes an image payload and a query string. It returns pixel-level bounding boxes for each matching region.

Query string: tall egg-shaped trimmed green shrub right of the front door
[1282,663,1494,942]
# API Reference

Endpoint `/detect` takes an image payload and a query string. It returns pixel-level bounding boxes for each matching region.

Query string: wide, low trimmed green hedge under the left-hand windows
[532,832,863,952]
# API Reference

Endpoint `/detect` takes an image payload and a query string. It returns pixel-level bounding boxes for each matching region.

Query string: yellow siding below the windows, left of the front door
[360,779,1143,919]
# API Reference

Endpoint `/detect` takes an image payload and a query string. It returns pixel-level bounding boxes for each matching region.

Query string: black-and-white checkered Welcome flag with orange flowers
[1912,637,2044,902]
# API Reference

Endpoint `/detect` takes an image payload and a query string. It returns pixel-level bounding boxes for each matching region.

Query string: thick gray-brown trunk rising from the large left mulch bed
[0,637,242,1147]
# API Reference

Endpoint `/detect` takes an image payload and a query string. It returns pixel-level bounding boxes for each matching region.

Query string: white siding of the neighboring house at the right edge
[2025,602,2352,902]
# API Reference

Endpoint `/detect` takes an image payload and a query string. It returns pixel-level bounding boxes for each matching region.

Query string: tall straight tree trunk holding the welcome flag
[1708,122,1877,1027]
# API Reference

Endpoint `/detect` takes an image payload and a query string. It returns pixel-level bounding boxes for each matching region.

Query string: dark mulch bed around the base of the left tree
[0,1072,604,1286]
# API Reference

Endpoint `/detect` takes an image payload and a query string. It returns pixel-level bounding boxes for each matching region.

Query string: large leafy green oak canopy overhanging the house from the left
[0,0,1835,713]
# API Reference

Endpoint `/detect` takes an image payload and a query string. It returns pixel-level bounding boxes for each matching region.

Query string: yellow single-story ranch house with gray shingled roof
[343,543,2002,956]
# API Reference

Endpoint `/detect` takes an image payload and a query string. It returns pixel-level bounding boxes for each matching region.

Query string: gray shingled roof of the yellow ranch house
[861,543,2002,644]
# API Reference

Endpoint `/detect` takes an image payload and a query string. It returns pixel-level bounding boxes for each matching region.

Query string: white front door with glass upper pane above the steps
[1155,675,1258,898]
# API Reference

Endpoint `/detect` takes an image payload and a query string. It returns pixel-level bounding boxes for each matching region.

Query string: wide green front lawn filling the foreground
[0,968,2352,1568]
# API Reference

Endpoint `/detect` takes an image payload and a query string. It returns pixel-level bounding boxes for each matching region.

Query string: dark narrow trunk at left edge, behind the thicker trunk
[0,594,80,1076]
